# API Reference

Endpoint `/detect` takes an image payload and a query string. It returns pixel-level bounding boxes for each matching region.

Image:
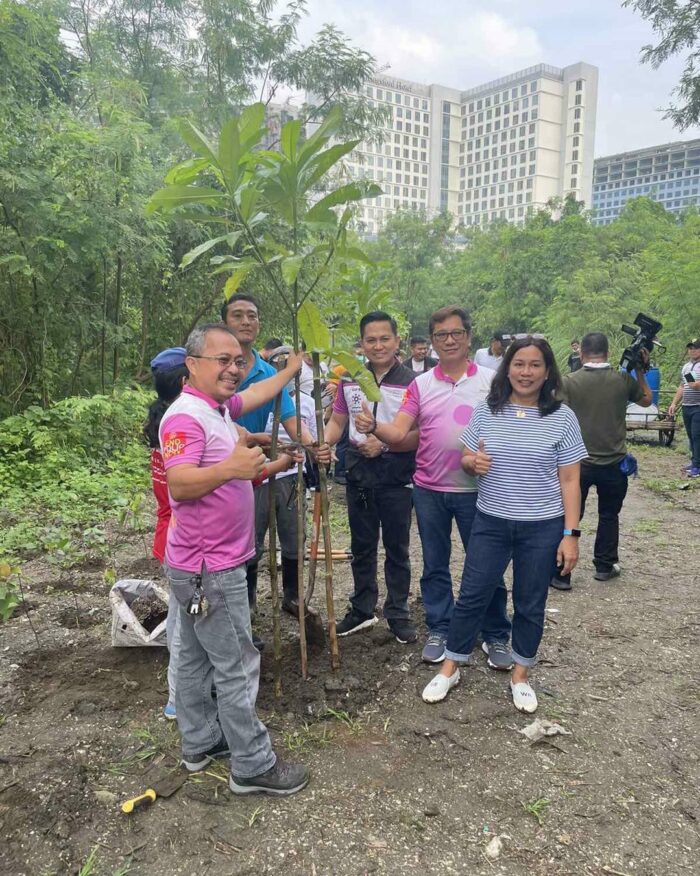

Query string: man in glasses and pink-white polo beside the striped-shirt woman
[356,306,512,670]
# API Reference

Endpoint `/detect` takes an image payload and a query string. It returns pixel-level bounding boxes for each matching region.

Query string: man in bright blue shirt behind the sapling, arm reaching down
[221,292,330,618]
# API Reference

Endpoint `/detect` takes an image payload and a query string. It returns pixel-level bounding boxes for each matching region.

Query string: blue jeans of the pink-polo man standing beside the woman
[413,485,510,642]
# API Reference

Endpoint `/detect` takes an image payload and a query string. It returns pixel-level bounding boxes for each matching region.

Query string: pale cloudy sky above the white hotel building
[290,0,700,156]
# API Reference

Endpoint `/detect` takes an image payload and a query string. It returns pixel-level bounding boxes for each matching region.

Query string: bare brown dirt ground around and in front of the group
[0,438,700,876]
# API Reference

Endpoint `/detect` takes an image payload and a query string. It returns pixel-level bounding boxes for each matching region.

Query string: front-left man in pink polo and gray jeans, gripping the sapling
[160,324,309,795]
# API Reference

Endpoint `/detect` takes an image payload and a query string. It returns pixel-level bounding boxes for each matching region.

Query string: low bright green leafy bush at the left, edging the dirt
[0,390,150,566]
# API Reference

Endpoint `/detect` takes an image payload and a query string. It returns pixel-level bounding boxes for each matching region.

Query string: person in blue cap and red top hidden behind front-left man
[143,347,189,721]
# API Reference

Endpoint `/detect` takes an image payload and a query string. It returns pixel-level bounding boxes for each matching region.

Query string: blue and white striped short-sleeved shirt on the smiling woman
[461,402,588,520]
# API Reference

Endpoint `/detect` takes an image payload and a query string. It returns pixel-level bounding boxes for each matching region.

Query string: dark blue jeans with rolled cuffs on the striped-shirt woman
[445,511,564,666]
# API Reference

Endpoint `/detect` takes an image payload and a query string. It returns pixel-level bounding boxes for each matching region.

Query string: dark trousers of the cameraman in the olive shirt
[560,462,627,581]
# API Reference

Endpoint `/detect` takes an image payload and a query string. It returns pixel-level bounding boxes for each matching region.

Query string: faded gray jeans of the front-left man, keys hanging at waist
[167,565,275,778]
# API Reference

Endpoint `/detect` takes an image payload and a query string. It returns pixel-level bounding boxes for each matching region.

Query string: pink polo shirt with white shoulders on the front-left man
[160,386,255,572]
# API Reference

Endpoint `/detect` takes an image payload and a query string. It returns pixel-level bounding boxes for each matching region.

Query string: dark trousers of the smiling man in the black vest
[346,483,412,621]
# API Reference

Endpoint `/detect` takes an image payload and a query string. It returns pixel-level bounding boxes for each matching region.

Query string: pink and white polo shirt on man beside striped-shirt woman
[401,362,496,493]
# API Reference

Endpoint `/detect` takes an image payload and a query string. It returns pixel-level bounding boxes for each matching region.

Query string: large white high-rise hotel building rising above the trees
[349,63,598,235]
